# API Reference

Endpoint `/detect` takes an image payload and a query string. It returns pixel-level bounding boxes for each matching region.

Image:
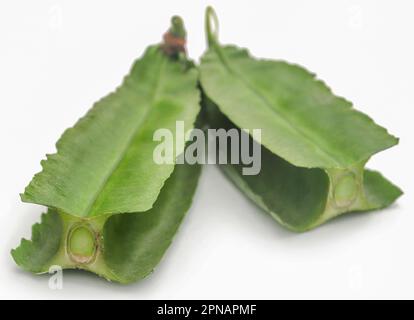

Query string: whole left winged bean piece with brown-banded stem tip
[12,17,204,283]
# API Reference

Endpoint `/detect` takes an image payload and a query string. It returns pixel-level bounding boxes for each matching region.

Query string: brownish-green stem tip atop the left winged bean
[162,16,187,56]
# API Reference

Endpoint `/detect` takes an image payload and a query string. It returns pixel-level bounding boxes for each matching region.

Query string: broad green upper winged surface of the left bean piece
[22,46,199,217]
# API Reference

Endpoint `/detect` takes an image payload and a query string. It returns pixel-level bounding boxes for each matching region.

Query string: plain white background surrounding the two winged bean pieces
[0,0,414,299]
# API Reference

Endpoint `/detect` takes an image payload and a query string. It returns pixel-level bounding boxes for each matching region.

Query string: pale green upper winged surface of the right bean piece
[200,44,398,168]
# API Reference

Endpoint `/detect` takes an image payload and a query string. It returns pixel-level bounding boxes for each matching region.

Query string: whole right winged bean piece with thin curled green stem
[199,8,401,231]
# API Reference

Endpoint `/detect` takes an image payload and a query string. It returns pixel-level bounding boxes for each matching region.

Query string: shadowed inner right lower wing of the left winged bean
[104,160,201,282]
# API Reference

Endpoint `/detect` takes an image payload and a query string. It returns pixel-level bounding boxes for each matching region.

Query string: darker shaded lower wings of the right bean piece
[203,98,402,232]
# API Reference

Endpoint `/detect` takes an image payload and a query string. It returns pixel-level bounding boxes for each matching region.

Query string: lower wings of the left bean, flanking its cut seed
[12,165,201,283]
